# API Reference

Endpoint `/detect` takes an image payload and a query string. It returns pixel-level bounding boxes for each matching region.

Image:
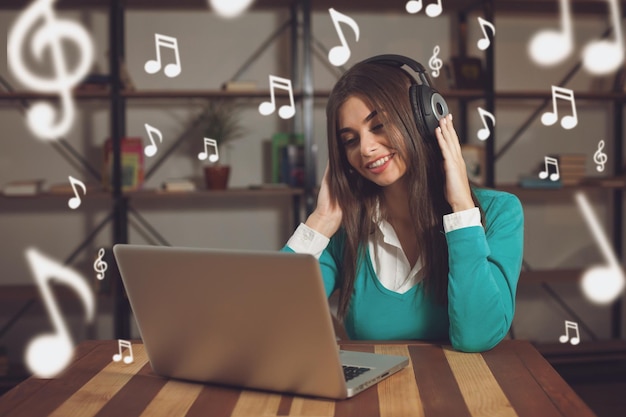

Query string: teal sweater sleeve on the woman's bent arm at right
[446,191,524,352]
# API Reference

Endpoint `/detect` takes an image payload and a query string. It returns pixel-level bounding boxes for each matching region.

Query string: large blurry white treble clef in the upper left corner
[7,0,94,140]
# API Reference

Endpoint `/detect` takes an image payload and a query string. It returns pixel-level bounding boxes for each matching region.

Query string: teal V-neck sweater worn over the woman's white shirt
[283,189,524,352]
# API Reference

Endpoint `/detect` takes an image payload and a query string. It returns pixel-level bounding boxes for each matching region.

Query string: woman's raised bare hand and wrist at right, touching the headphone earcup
[435,114,475,212]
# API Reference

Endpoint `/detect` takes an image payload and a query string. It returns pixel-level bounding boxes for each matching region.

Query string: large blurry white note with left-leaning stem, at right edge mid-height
[574,191,626,304]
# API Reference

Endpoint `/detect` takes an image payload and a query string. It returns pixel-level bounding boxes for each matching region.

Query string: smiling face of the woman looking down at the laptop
[337,96,406,187]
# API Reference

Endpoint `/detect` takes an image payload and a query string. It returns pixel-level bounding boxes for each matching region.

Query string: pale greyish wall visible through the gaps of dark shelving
[0,5,624,364]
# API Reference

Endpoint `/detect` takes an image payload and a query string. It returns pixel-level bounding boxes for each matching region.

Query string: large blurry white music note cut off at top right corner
[582,0,624,75]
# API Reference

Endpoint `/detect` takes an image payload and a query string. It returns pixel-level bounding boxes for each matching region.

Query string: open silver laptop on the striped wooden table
[113,245,408,399]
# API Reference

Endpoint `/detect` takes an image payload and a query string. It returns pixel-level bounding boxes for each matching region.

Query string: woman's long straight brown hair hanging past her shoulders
[326,59,477,318]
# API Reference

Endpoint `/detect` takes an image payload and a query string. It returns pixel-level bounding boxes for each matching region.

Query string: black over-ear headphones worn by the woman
[362,54,449,140]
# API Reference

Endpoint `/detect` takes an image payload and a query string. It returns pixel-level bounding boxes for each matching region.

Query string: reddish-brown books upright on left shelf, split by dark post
[102,137,144,191]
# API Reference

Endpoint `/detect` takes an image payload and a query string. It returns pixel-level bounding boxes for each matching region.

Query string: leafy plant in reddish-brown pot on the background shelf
[199,100,244,190]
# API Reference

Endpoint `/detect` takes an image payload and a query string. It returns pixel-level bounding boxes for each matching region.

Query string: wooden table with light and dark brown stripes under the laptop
[0,340,595,417]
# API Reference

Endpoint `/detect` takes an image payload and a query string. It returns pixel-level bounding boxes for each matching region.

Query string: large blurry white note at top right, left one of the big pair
[528,0,574,66]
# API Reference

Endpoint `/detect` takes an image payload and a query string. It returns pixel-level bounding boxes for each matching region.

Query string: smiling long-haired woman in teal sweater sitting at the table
[284,58,523,352]
